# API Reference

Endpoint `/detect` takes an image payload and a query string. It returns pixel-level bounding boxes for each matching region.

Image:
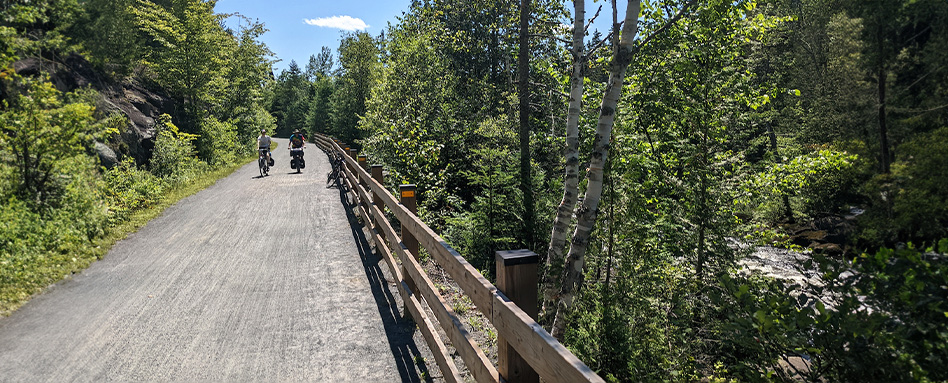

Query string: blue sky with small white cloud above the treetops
[215,0,625,73]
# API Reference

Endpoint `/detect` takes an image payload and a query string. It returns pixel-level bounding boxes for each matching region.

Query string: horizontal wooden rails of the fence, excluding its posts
[314,135,603,382]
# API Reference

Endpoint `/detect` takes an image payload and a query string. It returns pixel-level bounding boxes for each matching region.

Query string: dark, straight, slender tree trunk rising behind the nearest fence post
[517,0,534,252]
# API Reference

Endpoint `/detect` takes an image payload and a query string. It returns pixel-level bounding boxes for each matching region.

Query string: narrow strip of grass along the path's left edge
[0,156,256,317]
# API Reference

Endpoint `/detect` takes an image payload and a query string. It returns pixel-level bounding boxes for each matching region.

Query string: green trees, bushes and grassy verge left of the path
[0,0,273,315]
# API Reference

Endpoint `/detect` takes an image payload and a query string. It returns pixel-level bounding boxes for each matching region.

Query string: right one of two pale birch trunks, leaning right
[552,0,641,339]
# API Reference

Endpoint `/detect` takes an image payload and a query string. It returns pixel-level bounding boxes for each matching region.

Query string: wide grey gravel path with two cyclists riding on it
[0,140,428,382]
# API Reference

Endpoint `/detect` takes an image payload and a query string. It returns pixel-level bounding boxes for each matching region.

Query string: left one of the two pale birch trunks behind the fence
[541,0,586,315]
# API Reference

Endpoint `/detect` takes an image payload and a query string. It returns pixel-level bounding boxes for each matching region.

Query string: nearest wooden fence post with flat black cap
[495,250,540,383]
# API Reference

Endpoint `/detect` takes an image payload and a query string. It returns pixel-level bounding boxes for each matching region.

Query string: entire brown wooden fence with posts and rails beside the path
[313,135,603,382]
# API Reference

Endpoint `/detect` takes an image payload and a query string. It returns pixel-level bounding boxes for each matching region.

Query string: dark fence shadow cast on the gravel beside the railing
[339,188,431,382]
